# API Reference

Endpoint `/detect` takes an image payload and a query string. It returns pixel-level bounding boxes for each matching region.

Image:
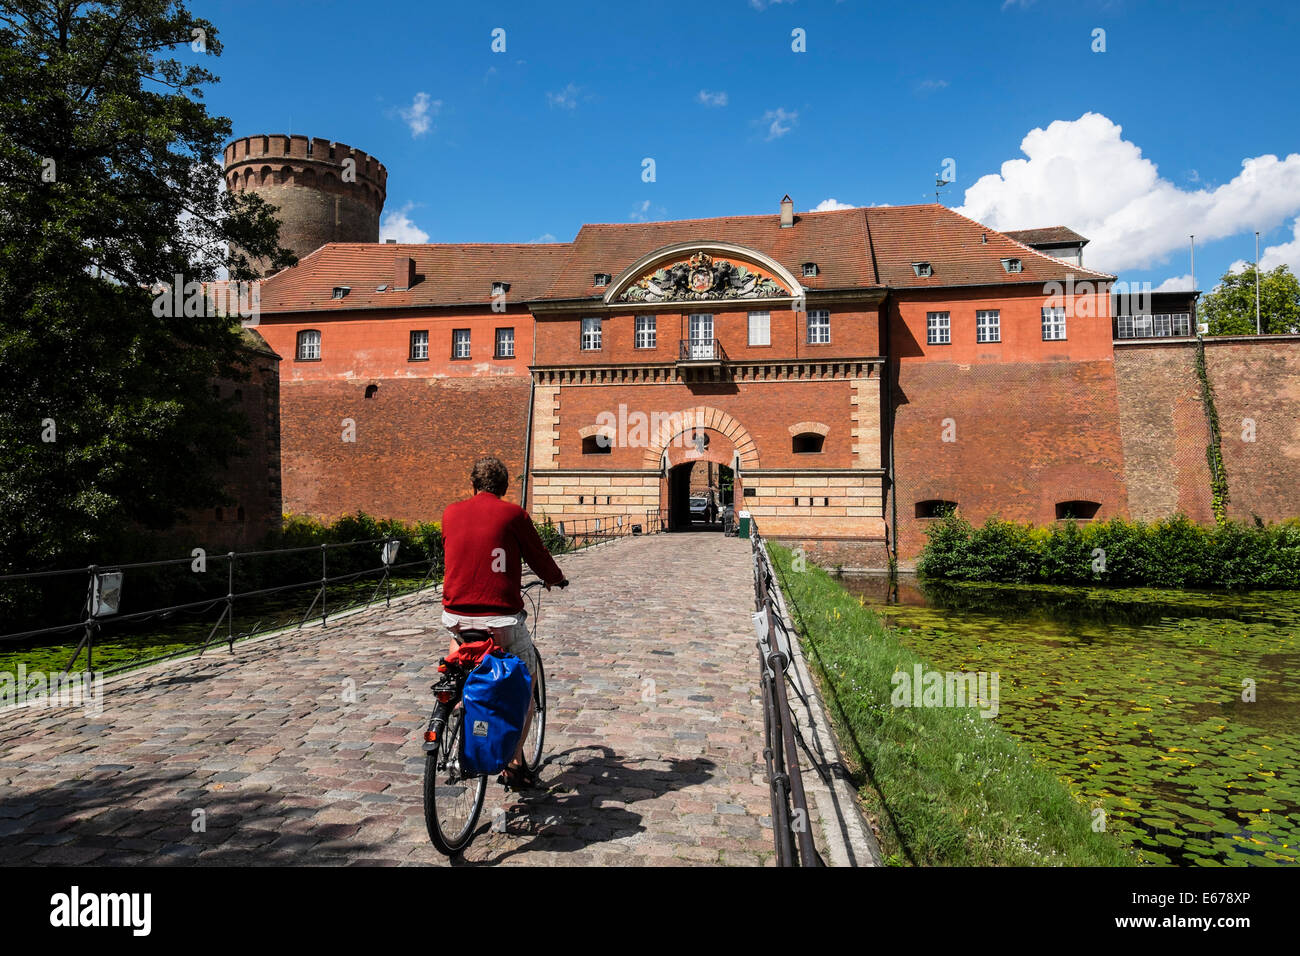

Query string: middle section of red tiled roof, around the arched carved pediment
[533,209,879,299]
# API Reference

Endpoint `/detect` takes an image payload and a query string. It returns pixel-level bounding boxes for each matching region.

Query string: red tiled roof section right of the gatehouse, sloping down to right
[866,203,1114,289]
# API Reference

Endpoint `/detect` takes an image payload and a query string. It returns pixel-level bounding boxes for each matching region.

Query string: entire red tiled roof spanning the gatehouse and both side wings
[261,203,1114,312]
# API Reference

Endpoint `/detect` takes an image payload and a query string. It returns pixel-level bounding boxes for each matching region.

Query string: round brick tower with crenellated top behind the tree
[225,135,389,274]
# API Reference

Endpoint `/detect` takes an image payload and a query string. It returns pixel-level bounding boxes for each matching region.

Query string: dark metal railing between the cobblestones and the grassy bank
[749,518,822,866]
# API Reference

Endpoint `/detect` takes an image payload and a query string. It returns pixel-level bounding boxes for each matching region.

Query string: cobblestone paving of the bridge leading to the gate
[0,533,772,865]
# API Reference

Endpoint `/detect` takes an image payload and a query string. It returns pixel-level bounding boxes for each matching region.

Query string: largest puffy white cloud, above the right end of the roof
[957,113,1300,272]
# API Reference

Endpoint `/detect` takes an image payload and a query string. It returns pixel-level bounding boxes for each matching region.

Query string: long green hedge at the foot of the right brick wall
[917,514,1300,589]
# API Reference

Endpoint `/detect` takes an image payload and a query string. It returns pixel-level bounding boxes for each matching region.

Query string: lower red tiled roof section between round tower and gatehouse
[261,242,569,312]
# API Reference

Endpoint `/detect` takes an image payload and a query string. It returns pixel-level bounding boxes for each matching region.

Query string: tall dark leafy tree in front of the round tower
[0,0,294,571]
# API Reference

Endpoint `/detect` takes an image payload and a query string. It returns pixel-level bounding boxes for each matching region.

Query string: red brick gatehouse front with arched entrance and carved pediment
[529,231,884,564]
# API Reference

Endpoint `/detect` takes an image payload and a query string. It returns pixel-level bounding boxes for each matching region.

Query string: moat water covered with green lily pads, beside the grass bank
[841,578,1300,866]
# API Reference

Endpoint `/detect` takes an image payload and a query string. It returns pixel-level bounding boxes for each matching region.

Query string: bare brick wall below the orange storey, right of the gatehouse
[885,362,1127,561]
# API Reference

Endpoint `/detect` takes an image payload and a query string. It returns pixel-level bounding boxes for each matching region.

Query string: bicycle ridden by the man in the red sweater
[424,580,556,856]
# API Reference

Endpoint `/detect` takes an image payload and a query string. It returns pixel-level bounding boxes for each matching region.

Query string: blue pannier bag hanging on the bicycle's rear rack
[460,652,533,774]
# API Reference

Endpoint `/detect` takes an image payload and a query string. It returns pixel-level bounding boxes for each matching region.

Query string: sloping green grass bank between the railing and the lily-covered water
[770,545,1134,866]
